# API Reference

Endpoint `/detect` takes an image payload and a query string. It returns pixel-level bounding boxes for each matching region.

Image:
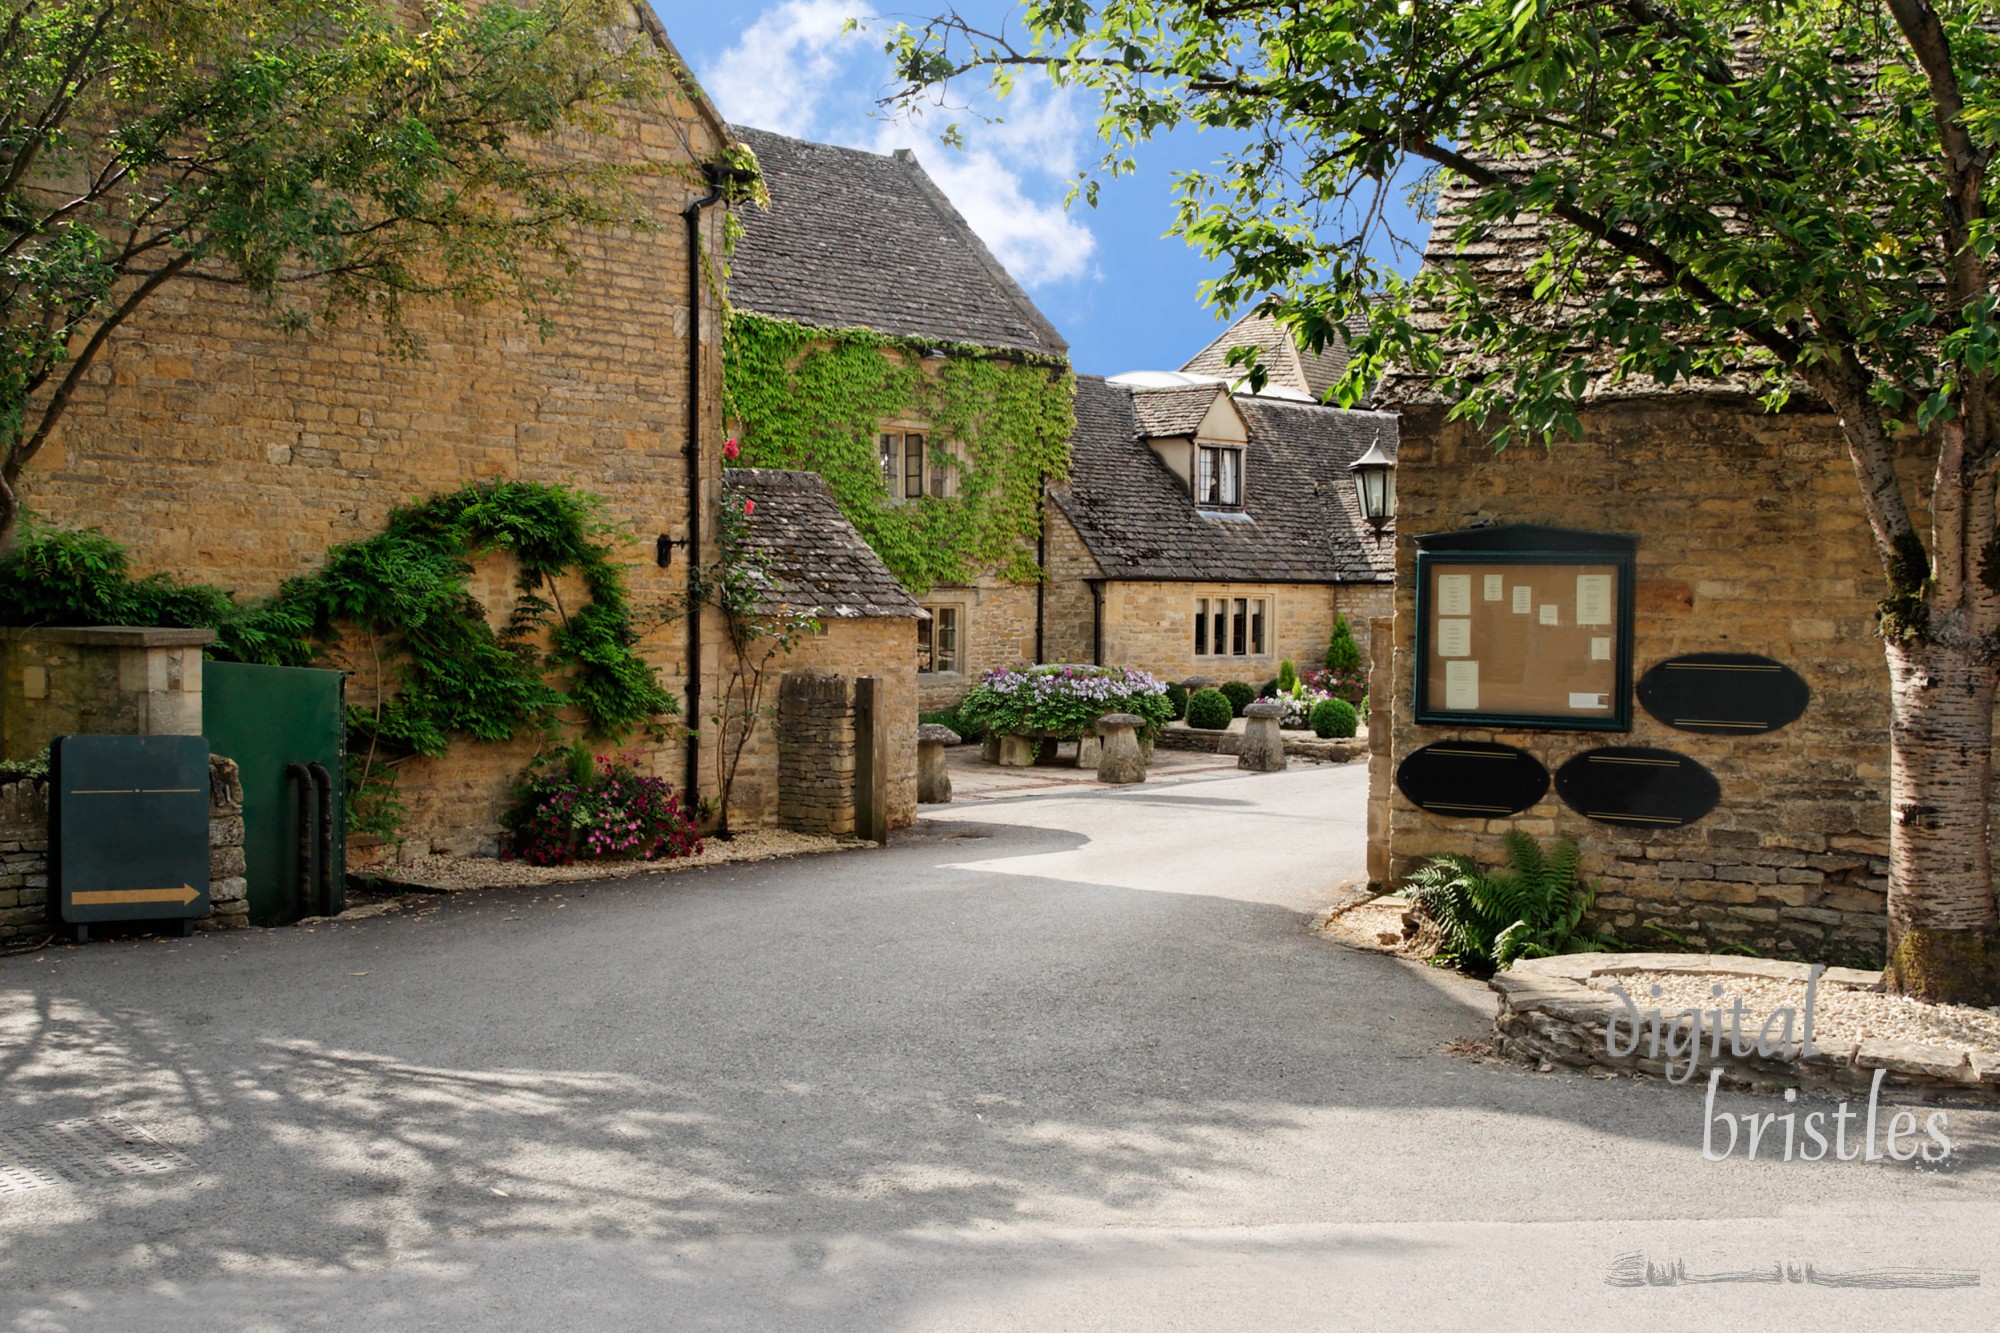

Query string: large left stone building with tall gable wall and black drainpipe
[5,4,732,851]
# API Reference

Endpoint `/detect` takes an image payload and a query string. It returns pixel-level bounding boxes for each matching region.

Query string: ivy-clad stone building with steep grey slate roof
[730,126,1070,709]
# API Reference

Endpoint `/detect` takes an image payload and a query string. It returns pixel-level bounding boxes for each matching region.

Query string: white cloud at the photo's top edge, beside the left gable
[702,0,874,138]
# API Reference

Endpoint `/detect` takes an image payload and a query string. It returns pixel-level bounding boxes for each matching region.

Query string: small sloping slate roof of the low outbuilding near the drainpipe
[722,468,926,620]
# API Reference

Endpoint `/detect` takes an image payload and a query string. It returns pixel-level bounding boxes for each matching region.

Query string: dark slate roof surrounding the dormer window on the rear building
[1050,376,1396,582]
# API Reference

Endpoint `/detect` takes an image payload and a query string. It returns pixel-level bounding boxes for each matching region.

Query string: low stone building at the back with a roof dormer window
[1046,376,1396,685]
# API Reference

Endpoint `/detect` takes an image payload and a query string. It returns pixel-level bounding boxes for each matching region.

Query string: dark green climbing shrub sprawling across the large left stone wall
[0,482,676,837]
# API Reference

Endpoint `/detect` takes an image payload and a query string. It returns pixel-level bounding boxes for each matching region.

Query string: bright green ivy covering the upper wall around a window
[722,310,1076,594]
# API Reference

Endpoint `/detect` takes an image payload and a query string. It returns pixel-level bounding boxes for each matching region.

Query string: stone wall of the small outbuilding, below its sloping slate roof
[730,616,918,831]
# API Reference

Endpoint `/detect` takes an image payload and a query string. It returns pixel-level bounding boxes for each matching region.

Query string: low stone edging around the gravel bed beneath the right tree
[1488,953,2000,1105]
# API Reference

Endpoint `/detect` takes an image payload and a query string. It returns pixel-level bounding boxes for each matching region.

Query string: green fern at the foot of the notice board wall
[1408,833,1606,977]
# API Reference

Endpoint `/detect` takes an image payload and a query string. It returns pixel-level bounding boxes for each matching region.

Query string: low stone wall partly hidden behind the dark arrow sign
[0,757,250,943]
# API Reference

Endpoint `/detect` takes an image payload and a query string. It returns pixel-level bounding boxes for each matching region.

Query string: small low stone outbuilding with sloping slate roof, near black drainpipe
[716,468,924,833]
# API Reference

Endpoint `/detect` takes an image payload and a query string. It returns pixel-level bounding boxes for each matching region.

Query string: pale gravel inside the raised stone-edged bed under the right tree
[1586,973,2000,1051]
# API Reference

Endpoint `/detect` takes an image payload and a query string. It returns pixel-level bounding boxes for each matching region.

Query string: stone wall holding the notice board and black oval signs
[1372,396,1888,963]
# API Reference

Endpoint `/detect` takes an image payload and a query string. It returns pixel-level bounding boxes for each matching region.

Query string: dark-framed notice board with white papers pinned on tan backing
[1416,552,1630,729]
